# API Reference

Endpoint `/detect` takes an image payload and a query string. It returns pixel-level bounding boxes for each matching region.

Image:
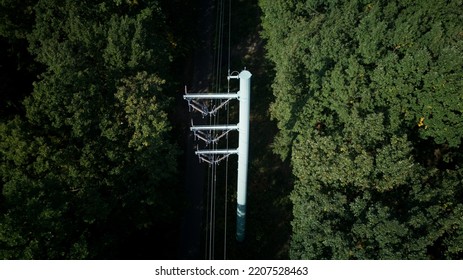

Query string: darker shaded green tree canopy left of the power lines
[0,0,178,259]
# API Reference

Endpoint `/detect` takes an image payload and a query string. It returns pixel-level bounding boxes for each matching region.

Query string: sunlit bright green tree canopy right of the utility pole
[260,0,463,259]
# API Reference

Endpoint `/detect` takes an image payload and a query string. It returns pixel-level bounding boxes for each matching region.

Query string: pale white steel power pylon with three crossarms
[183,70,252,241]
